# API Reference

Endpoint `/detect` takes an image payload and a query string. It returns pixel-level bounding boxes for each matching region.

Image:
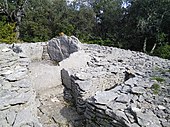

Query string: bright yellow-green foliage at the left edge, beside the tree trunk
[0,21,17,44]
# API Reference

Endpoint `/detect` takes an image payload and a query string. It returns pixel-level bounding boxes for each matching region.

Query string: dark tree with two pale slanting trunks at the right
[124,0,170,53]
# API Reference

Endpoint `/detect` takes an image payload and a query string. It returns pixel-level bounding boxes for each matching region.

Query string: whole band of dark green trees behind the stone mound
[0,0,170,58]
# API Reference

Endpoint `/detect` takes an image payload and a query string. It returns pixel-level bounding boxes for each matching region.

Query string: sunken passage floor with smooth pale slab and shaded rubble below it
[29,61,84,127]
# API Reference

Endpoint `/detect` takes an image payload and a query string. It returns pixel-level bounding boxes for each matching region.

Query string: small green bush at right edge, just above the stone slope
[154,44,170,60]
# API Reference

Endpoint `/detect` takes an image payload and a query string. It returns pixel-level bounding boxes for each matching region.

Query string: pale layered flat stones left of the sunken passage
[0,44,42,127]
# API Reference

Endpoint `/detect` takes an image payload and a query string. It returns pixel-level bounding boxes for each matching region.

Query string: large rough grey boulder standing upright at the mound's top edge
[47,35,80,62]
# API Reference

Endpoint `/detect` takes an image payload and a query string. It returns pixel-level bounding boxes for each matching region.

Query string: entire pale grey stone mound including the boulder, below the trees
[0,36,170,127]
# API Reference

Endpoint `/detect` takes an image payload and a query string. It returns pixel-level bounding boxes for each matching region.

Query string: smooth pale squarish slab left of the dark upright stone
[29,62,61,90]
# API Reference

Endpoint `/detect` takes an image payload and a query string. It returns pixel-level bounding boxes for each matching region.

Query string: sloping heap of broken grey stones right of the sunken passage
[61,44,170,127]
